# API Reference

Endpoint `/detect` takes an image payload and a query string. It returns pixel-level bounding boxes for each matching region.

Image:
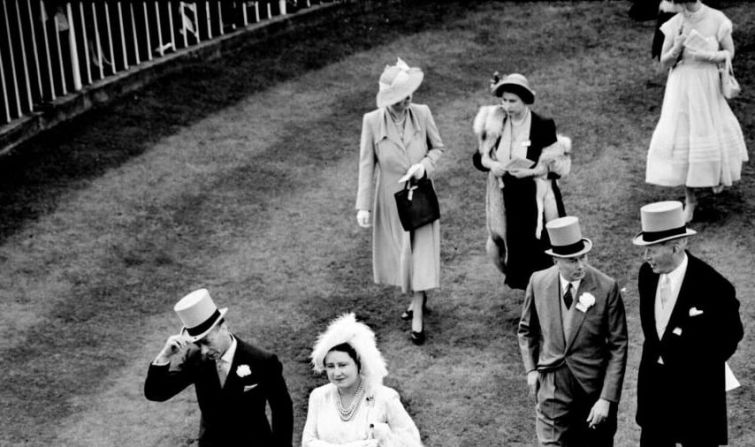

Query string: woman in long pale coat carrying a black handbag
[356,59,443,344]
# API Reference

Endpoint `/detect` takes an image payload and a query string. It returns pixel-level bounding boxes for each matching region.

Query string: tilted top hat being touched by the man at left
[173,289,228,342]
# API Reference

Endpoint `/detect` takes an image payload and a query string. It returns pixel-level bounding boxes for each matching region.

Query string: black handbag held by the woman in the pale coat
[394,177,440,231]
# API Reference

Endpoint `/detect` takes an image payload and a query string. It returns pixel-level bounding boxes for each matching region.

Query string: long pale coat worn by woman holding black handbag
[356,104,444,292]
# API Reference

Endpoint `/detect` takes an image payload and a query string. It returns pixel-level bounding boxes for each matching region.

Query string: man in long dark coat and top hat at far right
[633,201,743,447]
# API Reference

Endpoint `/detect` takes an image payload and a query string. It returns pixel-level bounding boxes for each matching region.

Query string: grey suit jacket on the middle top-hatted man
[518,266,628,402]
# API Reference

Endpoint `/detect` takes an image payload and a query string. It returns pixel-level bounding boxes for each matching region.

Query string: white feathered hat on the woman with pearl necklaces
[311,313,388,387]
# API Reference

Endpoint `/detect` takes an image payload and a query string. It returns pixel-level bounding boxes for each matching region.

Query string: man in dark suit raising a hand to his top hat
[144,289,293,447]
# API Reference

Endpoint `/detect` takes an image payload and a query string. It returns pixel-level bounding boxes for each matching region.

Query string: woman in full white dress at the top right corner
[645,0,748,222]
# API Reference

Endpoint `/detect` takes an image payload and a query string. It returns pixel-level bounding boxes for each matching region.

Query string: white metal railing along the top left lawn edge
[0,0,334,125]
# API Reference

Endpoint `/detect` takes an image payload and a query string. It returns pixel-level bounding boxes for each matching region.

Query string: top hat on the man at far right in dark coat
[632,200,697,245]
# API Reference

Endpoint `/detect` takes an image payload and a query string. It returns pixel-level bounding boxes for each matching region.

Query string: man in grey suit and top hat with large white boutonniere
[518,216,627,447]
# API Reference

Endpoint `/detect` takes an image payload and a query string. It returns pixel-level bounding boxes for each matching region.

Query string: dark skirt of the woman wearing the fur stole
[503,175,563,289]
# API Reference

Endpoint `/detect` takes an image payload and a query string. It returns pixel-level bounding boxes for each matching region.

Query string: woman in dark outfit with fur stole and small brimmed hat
[473,73,571,289]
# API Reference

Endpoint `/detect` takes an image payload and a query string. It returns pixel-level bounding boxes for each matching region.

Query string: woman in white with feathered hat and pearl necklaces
[302,313,422,447]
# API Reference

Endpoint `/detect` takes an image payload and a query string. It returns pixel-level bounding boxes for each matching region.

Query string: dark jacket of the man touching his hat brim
[144,337,293,447]
